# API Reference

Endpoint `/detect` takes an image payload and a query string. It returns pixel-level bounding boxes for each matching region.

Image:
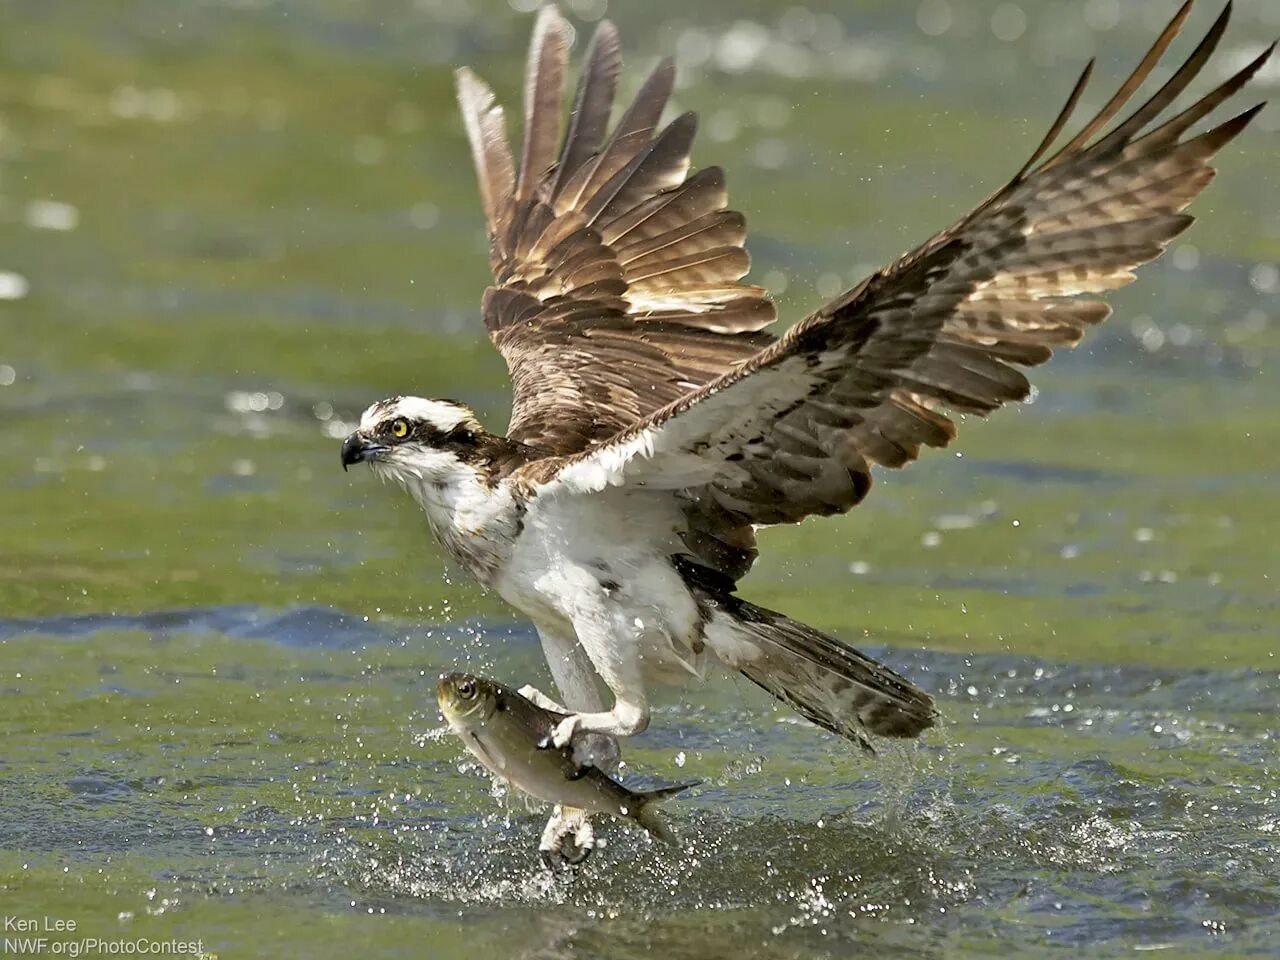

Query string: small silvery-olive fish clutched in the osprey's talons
[435,673,696,846]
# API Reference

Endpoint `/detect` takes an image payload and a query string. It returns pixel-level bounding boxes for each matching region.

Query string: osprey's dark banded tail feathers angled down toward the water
[686,560,938,753]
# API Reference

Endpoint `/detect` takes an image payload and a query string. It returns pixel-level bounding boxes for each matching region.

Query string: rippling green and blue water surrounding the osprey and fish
[0,0,1280,959]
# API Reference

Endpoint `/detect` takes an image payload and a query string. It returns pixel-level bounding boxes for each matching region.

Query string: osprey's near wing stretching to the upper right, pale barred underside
[525,3,1271,535]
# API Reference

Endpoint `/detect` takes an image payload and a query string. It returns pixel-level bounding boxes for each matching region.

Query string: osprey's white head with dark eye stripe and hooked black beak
[342,397,486,494]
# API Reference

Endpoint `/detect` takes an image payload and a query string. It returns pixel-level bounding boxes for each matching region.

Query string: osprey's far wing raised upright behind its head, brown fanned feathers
[458,8,776,454]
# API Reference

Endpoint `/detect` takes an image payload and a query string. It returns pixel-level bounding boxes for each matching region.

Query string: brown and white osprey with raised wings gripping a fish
[342,0,1271,856]
